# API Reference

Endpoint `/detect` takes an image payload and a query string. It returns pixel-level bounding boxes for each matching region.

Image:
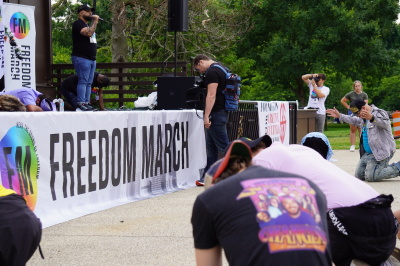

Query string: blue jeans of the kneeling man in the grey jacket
[355,153,400,182]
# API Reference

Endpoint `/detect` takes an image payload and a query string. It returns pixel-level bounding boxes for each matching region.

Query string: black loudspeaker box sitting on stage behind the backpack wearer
[157,77,196,110]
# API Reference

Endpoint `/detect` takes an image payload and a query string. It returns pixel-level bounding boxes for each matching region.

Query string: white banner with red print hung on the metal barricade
[257,101,290,145]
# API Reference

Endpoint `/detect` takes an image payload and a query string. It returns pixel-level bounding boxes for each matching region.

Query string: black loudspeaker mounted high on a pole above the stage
[168,0,188,31]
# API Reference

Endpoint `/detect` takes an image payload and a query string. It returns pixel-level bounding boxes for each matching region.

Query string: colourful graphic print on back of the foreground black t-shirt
[236,178,327,253]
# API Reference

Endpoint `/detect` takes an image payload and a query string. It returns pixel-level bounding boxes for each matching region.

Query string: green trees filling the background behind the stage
[52,0,400,112]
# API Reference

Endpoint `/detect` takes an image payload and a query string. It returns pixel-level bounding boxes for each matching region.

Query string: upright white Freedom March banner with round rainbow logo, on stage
[2,3,36,90]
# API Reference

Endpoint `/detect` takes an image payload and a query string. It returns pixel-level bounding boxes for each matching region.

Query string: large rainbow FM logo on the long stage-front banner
[0,124,39,210]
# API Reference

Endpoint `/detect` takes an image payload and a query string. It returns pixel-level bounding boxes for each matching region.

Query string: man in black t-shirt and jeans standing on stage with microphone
[71,4,99,111]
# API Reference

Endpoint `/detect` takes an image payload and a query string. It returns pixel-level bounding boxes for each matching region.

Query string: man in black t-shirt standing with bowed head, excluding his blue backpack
[194,54,229,186]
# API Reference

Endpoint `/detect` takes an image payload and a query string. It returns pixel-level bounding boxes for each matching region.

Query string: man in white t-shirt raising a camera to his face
[301,73,330,133]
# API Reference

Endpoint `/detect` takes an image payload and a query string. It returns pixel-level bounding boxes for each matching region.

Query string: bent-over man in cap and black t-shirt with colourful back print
[191,141,332,266]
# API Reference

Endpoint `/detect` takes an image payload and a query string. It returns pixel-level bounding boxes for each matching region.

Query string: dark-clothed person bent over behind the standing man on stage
[61,72,110,111]
